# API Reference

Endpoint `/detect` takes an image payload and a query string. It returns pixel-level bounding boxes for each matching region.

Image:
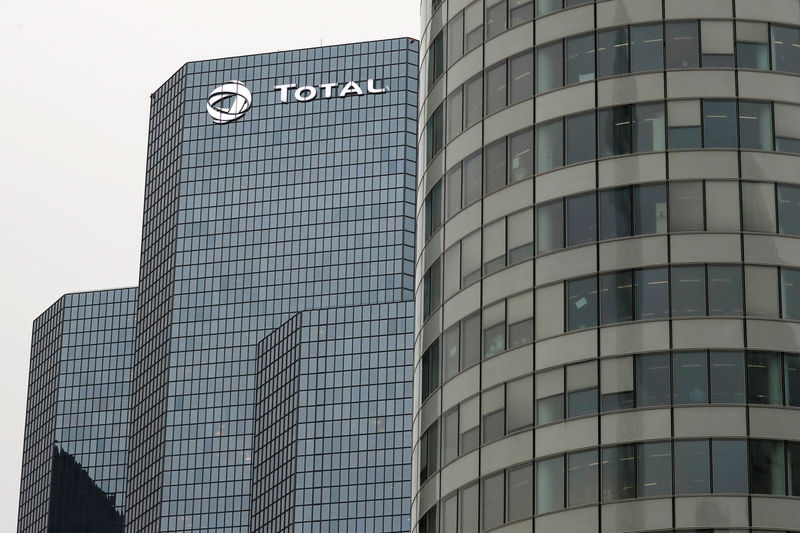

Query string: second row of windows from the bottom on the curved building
[419,348,800,470]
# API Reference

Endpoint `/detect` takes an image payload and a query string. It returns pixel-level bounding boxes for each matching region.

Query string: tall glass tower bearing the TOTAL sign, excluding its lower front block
[126,39,418,532]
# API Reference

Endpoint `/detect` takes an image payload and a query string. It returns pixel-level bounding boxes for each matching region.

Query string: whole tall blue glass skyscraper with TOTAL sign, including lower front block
[20,39,418,532]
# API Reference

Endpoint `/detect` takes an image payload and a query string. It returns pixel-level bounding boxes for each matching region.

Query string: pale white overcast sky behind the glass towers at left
[0,0,420,531]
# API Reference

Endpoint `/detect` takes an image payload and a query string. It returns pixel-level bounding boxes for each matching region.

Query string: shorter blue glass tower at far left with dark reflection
[18,288,136,533]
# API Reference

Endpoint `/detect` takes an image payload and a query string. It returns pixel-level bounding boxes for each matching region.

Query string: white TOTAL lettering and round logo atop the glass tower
[206,79,389,124]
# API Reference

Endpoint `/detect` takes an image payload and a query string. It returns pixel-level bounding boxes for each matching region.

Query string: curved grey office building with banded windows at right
[412,0,800,533]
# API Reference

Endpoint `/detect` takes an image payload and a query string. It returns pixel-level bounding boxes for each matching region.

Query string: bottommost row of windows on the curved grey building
[419,439,800,533]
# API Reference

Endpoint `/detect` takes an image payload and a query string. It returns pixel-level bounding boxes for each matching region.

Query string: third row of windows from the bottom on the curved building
[420,264,800,401]
